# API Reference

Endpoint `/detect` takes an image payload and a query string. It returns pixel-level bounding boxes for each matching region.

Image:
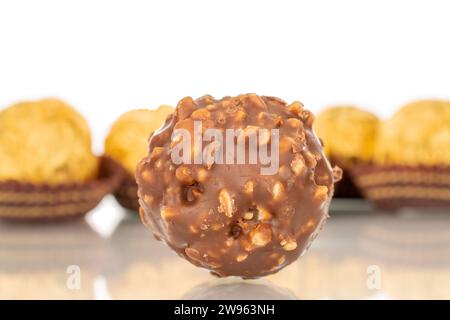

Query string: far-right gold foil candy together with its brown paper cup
[352,100,450,209]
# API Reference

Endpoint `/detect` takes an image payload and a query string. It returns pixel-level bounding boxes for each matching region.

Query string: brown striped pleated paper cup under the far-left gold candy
[0,157,122,220]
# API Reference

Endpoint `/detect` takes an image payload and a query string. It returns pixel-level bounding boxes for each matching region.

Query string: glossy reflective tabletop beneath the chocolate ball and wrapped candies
[0,198,450,299]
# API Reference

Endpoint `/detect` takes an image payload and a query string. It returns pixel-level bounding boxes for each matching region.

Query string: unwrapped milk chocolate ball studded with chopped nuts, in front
[136,94,335,278]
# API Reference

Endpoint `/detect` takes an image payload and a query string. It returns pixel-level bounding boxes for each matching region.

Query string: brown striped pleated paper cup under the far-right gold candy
[350,164,450,210]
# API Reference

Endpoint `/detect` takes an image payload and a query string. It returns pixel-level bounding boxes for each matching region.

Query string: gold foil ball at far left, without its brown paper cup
[0,99,98,184]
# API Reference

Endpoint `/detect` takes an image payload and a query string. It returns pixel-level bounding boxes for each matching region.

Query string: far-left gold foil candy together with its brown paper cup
[0,99,120,219]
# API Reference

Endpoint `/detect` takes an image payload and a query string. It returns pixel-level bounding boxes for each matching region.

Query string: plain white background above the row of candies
[0,0,450,152]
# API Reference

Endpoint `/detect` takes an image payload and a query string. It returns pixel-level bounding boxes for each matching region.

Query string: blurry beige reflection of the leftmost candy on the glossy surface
[0,220,106,299]
